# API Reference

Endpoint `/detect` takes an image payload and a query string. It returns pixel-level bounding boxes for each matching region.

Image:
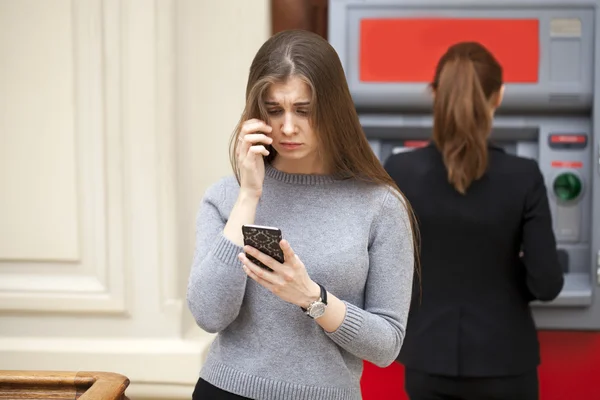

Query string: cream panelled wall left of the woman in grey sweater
[0,0,270,400]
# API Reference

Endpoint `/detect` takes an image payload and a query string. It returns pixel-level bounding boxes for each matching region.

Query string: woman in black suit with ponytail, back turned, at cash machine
[386,43,563,400]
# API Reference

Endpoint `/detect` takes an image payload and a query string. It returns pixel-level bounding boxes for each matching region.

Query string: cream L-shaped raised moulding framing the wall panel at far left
[0,0,129,314]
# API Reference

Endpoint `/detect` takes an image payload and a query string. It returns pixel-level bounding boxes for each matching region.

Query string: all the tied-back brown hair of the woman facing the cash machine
[431,42,502,194]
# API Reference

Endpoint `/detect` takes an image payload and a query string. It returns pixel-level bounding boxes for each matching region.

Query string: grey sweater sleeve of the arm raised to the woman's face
[187,182,247,333]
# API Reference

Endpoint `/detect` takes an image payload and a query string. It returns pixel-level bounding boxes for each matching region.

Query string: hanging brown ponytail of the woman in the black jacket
[433,57,492,194]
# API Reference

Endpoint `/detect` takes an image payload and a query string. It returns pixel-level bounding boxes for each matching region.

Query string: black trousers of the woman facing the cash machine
[404,368,539,400]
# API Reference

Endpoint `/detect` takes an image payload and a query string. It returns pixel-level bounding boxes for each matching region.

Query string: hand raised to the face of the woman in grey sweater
[236,119,273,197]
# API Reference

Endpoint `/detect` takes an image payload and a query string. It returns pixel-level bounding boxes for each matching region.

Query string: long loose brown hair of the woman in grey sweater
[230,30,419,273]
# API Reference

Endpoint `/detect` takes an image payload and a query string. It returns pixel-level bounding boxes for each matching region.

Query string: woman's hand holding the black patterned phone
[239,240,321,308]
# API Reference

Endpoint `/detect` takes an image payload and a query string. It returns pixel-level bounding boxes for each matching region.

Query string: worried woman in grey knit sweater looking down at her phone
[188,31,415,400]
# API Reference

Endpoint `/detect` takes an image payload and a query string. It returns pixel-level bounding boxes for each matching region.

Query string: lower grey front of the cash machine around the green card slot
[361,115,600,329]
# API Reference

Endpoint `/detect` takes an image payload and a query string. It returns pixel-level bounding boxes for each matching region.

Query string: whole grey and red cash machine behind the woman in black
[328,0,600,400]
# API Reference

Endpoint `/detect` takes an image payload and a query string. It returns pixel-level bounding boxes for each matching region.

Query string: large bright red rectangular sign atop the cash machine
[359,18,540,83]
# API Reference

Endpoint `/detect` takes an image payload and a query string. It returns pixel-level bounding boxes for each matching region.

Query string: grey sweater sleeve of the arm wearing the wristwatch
[328,191,414,367]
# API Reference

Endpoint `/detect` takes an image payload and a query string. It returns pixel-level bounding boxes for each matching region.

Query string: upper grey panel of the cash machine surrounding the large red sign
[329,0,596,113]
